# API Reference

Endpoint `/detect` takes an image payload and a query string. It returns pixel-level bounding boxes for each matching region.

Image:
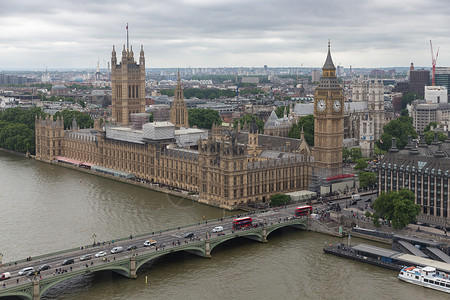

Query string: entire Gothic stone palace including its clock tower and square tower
[35,40,343,209]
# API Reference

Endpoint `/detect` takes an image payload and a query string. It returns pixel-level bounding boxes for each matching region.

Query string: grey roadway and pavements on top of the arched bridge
[0,205,306,294]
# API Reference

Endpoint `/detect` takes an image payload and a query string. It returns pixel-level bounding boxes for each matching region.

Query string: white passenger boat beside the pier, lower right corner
[398,267,450,294]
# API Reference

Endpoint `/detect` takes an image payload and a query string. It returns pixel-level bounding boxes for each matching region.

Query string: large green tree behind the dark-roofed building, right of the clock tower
[376,116,417,151]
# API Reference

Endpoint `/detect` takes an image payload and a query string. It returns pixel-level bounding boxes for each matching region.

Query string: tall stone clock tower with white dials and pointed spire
[313,42,344,177]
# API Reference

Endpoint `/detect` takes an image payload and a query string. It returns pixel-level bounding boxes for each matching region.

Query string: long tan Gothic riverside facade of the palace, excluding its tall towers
[36,118,314,209]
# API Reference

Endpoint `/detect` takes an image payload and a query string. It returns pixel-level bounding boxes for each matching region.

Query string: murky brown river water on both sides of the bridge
[0,152,446,300]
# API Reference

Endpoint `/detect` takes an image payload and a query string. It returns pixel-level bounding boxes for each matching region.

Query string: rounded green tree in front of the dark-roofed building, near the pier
[373,189,420,229]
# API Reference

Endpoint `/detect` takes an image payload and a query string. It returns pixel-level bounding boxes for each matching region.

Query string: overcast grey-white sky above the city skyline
[0,0,450,70]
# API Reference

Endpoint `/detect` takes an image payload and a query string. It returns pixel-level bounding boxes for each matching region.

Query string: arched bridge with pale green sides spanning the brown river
[0,206,310,300]
